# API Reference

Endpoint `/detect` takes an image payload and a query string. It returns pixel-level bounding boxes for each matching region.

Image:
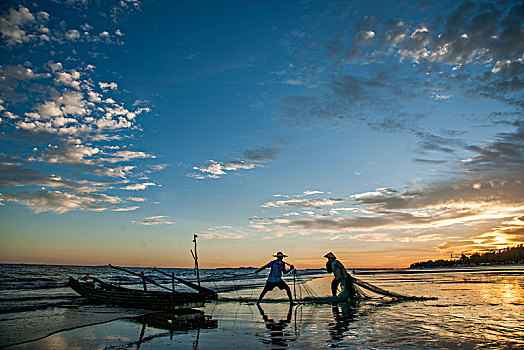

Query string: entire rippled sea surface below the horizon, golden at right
[0,265,524,349]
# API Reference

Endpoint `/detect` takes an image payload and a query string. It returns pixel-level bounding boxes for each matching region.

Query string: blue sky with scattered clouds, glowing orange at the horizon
[0,0,524,268]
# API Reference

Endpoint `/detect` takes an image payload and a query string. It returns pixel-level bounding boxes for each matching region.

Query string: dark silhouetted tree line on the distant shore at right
[409,244,524,269]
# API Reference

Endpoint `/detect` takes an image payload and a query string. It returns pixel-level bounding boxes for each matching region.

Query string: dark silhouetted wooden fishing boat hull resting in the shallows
[67,277,216,310]
